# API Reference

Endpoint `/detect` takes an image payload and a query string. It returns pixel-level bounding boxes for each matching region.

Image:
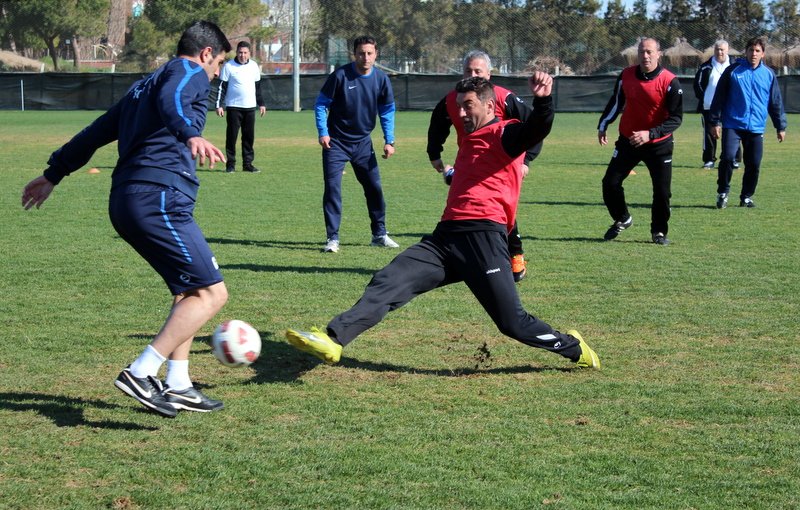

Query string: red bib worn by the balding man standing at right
[619,66,675,143]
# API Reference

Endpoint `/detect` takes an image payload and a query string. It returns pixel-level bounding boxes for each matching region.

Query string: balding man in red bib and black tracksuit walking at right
[597,38,683,245]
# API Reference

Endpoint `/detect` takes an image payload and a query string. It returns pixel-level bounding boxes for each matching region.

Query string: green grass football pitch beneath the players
[0,111,800,509]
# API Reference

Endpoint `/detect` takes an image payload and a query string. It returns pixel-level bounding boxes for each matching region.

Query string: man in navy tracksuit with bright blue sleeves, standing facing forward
[314,36,398,253]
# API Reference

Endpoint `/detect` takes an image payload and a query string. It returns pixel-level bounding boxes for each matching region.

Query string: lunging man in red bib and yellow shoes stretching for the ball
[286,72,600,368]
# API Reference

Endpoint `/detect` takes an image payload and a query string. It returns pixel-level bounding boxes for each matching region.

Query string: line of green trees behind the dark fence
[0,0,800,74]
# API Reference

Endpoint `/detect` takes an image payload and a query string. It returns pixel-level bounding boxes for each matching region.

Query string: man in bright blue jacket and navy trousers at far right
[711,37,786,209]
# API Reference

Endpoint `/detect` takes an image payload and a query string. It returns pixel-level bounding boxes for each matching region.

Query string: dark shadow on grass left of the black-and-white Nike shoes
[0,392,158,430]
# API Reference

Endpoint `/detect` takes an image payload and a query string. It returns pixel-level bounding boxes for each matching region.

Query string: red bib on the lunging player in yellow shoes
[442,118,525,232]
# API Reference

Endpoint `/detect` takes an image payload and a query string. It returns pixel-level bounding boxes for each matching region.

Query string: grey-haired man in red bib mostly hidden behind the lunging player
[427,50,542,282]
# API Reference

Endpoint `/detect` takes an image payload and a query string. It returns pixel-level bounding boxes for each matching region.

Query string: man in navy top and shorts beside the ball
[22,21,231,417]
